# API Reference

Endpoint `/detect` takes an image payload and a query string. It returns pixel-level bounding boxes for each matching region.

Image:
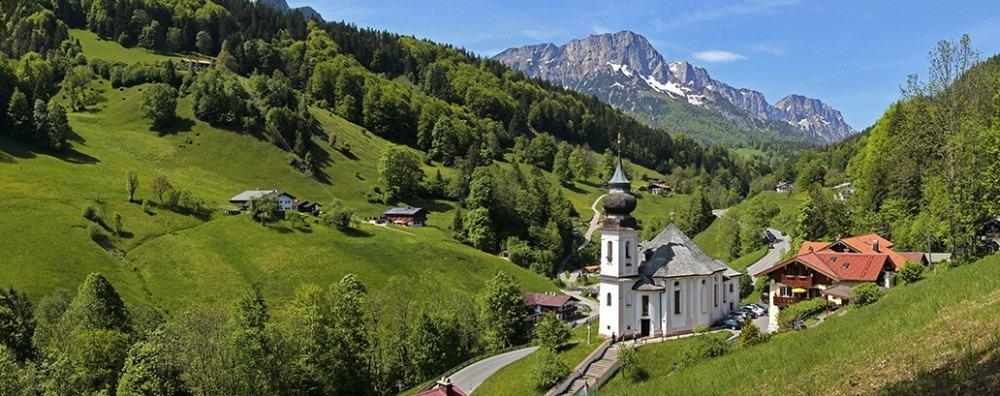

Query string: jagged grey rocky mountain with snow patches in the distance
[495,31,856,142]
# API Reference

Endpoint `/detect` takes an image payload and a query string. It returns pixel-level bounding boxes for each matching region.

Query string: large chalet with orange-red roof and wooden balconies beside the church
[753,234,928,328]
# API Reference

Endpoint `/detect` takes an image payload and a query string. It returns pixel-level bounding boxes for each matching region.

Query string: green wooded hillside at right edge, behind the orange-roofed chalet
[777,36,1000,261]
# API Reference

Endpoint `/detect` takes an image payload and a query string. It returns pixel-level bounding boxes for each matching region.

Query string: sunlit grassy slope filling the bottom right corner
[602,256,1000,395]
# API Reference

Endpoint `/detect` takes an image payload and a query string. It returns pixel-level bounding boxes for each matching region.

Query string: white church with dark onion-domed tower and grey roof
[598,157,742,338]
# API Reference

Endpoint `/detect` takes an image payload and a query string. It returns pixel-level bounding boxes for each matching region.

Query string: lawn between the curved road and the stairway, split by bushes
[475,321,603,396]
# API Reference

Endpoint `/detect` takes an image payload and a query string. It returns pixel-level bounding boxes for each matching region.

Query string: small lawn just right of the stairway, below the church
[600,332,730,394]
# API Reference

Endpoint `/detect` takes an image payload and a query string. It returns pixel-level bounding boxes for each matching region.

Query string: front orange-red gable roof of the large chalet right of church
[756,252,889,282]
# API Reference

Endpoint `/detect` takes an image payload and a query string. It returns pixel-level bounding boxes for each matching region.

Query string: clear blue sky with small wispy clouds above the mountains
[289,0,1000,130]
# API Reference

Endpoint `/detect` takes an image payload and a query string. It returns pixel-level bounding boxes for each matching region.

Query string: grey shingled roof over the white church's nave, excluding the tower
[639,224,732,278]
